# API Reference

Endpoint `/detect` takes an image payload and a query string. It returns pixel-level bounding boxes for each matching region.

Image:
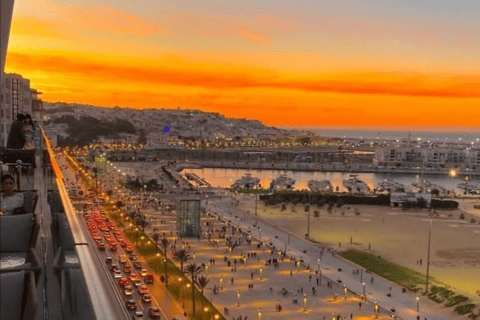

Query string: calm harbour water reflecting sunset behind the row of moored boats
[184,168,478,193]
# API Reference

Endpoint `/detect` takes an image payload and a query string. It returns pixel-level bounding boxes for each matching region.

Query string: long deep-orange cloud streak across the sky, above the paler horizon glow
[8,53,480,98]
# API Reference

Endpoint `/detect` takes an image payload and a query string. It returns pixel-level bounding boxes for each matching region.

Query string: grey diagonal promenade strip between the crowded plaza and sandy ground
[203,199,451,320]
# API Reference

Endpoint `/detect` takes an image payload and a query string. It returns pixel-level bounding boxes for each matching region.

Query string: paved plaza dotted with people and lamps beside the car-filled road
[143,206,398,320]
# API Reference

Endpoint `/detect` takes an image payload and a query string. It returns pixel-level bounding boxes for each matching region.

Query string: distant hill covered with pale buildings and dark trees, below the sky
[44,102,314,144]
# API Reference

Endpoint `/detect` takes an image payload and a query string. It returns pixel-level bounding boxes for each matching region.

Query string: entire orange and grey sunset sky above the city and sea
[5,0,480,130]
